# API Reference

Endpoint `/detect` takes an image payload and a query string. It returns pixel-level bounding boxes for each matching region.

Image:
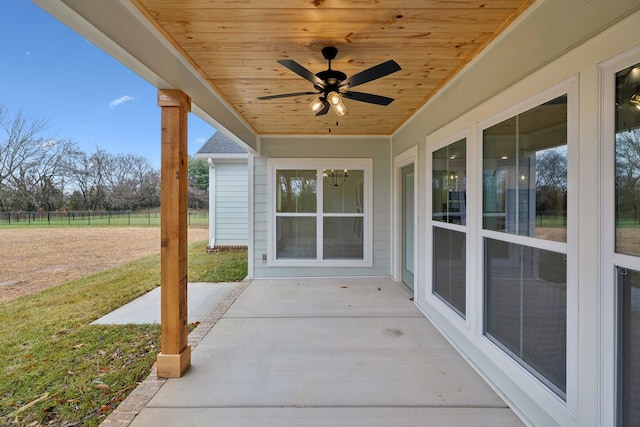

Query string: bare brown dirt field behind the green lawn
[0,227,209,302]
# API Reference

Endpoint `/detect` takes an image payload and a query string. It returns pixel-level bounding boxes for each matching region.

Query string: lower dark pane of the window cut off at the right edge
[618,268,640,427]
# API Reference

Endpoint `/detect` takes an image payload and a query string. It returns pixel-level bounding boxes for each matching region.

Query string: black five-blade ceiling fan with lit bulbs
[258,46,401,116]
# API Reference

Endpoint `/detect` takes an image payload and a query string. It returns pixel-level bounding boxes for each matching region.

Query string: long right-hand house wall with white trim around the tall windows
[392,6,640,426]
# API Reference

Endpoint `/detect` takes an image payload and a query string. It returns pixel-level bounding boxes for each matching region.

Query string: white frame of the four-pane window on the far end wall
[267,158,373,267]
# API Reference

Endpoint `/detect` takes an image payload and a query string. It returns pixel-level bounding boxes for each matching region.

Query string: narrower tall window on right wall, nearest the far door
[431,139,467,318]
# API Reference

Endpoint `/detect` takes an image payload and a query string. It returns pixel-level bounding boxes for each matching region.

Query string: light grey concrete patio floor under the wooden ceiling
[126,278,523,427]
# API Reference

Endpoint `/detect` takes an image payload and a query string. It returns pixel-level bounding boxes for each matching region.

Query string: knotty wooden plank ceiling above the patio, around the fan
[133,0,534,135]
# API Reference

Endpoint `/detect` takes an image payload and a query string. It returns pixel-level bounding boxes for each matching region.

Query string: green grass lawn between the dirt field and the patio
[0,242,247,426]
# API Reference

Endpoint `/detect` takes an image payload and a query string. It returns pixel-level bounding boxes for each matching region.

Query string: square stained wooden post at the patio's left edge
[157,89,191,378]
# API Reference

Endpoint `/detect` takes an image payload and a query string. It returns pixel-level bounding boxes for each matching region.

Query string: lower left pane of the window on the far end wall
[276,217,317,259]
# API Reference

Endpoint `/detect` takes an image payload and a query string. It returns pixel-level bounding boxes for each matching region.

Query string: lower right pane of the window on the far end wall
[323,217,364,259]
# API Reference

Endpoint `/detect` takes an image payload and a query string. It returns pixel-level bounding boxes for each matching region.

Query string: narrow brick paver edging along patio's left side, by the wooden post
[100,280,251,427]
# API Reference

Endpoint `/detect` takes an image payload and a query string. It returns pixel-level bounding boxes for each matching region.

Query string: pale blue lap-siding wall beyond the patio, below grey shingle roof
[209,160,249,246]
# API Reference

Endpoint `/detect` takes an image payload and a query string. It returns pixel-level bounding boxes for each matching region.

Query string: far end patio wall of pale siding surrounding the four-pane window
[251,137,391,278]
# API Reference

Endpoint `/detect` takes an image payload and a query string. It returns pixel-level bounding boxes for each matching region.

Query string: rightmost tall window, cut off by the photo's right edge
[614,64,640,427]
